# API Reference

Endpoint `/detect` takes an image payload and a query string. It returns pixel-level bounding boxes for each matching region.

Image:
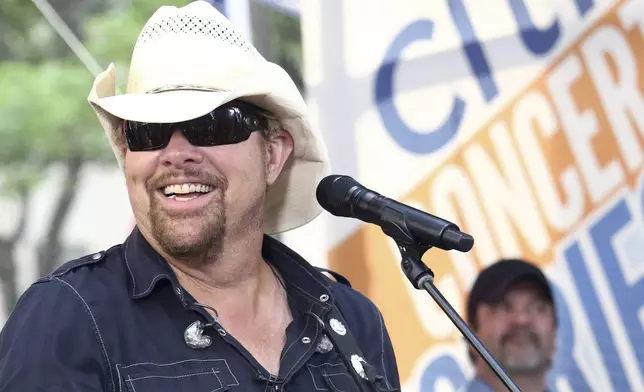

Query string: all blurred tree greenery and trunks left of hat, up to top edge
[0,0,189,313]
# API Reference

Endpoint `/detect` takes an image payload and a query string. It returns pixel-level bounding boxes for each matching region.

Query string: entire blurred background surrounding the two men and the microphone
[0,0,644,392]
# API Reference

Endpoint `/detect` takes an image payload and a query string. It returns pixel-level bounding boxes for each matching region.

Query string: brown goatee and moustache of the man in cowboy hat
[148,169,228,264]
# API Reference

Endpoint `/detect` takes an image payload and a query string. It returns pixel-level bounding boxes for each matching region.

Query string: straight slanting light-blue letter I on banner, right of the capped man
[565,243,628,390]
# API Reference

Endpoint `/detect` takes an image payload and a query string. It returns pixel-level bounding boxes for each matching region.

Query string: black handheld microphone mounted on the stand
[315,175,474,252]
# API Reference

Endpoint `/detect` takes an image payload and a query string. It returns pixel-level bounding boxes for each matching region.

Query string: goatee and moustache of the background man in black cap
[498,328,550,374]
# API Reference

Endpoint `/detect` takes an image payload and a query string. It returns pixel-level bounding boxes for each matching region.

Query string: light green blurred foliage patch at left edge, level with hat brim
[0,60,111,191]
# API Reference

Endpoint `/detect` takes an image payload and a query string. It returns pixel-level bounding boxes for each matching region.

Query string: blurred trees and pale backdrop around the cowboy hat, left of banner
[0,0,304,320]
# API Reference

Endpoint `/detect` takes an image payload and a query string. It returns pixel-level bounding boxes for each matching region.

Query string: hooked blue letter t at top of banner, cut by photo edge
[510,0,561,55]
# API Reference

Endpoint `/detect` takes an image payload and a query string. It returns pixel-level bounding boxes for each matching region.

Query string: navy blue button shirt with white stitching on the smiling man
[0,229,400,392]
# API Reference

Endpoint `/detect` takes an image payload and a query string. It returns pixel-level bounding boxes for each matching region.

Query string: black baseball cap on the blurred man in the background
[467,259,554,327]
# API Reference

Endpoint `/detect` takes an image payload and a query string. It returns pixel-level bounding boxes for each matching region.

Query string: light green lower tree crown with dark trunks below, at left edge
[0,60,111,307]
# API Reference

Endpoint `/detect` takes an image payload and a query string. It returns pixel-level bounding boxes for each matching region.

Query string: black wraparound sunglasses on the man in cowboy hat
[123,101,268,151]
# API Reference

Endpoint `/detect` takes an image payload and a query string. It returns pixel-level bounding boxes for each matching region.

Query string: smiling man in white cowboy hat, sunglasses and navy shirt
[0,1,400,392]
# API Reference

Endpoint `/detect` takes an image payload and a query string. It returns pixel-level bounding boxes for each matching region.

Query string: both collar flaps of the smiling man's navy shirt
[124,227,333,308]
